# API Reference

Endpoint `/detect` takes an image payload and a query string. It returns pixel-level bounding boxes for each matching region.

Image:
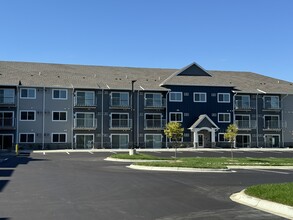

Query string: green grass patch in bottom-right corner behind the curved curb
[245,183,293,206]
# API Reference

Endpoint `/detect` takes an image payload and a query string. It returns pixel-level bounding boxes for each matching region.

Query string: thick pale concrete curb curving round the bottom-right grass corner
[230,190,293,219]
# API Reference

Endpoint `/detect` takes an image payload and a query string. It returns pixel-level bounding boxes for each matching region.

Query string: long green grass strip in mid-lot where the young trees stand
[136,157,293,169]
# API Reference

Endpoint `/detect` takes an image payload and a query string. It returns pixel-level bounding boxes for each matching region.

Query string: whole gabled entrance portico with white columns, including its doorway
[189,115,219,148]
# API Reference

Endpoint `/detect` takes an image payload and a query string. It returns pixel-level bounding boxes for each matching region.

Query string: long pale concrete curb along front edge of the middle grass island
[127,164,236,173]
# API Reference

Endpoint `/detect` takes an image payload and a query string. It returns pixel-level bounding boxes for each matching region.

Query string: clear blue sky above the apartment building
[0,0,293,82]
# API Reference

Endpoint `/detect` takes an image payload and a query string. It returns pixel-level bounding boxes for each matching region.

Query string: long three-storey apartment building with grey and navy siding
[0,62,293,150]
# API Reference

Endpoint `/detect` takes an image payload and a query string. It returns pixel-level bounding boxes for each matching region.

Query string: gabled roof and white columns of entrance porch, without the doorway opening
[189,115,219,147]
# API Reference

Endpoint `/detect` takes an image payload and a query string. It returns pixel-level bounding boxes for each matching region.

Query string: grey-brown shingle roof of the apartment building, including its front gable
[0,61,293,94]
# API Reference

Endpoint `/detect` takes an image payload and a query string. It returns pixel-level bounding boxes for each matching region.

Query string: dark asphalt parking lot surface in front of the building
[0,151,293,220]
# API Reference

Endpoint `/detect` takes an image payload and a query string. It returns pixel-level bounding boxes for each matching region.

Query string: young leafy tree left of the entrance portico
[164,122,184,158]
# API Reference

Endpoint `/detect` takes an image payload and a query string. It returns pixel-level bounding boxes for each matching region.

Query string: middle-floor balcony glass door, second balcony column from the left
[74,112,96,128]
